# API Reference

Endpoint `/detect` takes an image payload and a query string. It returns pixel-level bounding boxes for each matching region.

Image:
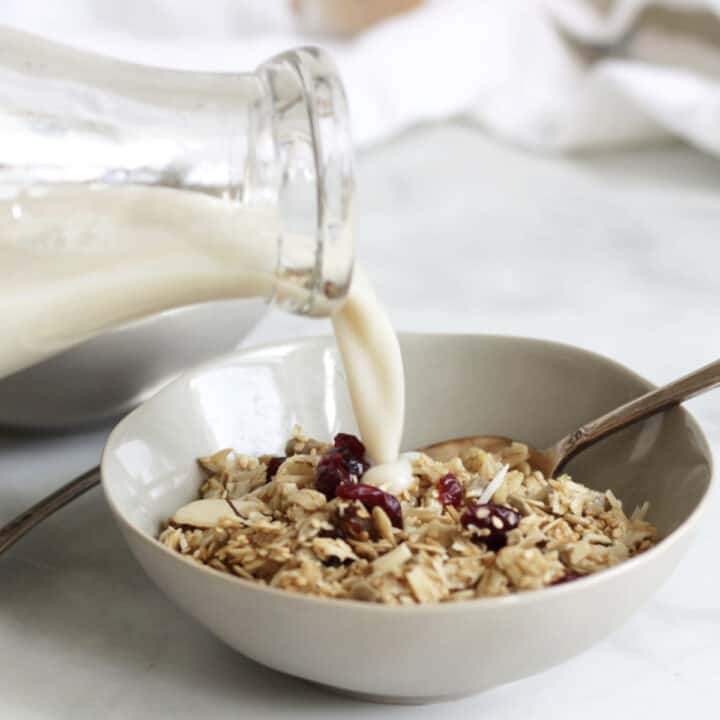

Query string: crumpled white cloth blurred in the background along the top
[0,0,720,154]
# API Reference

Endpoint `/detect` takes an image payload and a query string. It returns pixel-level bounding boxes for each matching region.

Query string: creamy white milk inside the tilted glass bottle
[0,187,278,377]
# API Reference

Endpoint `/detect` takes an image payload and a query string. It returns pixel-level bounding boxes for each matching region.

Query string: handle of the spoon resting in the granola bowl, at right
[554,360,720,469]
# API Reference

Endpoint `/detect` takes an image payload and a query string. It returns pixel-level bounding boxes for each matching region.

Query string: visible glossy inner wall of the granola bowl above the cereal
[103,335,712,536]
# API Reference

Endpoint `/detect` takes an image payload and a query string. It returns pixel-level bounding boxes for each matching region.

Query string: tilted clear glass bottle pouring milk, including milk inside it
[0,29,353,394]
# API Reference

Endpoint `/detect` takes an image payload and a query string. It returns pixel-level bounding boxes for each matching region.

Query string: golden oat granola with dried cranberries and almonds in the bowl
[159,429,656,605]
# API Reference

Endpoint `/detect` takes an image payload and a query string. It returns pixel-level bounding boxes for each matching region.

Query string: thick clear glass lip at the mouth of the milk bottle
[258,47,354,315]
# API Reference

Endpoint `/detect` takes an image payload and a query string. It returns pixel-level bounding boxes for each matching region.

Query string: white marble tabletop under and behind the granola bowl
[0,126,720,720]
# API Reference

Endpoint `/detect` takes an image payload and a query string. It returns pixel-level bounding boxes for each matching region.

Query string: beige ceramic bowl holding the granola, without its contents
[102,335,712,702]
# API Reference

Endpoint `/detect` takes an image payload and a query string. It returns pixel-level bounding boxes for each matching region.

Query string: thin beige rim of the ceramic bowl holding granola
[100,332,717,615]
